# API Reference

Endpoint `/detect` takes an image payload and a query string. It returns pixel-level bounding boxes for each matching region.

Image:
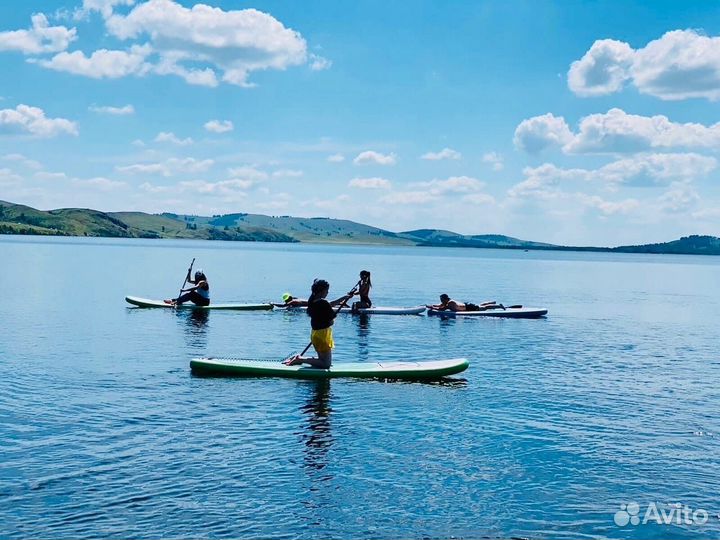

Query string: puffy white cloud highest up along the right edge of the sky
[568,30,720,101]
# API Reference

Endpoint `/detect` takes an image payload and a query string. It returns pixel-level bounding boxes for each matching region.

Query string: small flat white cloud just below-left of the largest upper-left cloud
[38,45,152,79]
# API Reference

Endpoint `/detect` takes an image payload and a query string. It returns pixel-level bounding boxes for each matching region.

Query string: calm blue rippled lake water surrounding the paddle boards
[0,236,720,539]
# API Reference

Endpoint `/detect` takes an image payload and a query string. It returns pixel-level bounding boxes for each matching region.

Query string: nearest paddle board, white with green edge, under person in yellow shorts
[190,358,469,380]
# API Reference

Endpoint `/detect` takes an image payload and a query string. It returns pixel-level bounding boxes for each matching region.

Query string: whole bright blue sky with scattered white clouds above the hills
[0,0,720,245]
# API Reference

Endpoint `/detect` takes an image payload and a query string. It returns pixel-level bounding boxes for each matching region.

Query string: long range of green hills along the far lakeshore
[0,201,720,255]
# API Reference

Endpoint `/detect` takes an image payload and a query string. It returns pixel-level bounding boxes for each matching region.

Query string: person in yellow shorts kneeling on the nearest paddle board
[283,279,346,369]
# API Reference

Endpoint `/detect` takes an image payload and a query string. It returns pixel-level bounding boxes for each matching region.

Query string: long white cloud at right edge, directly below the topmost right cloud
[515,108,720,154]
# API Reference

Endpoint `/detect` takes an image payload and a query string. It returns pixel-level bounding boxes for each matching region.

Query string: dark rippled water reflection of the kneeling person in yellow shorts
[301,379,334,471]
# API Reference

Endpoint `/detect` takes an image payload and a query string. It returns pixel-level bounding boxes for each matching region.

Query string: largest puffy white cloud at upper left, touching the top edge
[105,0,310,87]
